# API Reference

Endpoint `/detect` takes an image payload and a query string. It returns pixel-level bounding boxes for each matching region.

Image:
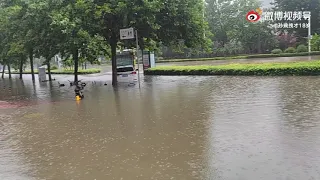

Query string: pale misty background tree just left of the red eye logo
[205,0,276,55]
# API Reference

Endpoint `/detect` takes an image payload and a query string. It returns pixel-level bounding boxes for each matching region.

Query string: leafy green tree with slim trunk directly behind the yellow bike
[51,0,107,82]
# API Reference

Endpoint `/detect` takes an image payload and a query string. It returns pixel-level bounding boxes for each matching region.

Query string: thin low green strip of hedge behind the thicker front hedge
[157,51,320,63]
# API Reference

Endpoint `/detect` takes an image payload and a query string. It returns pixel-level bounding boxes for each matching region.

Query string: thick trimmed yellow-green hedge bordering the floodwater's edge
[145,60,320,76]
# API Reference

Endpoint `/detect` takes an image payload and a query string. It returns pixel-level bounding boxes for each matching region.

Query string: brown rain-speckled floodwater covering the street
[0,75,320,180]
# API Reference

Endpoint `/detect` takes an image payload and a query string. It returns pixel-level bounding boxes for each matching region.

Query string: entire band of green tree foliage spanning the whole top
[0,0,320,83]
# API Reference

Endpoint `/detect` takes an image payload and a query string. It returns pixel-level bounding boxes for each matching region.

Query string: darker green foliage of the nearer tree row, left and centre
[0,0,209,84]
